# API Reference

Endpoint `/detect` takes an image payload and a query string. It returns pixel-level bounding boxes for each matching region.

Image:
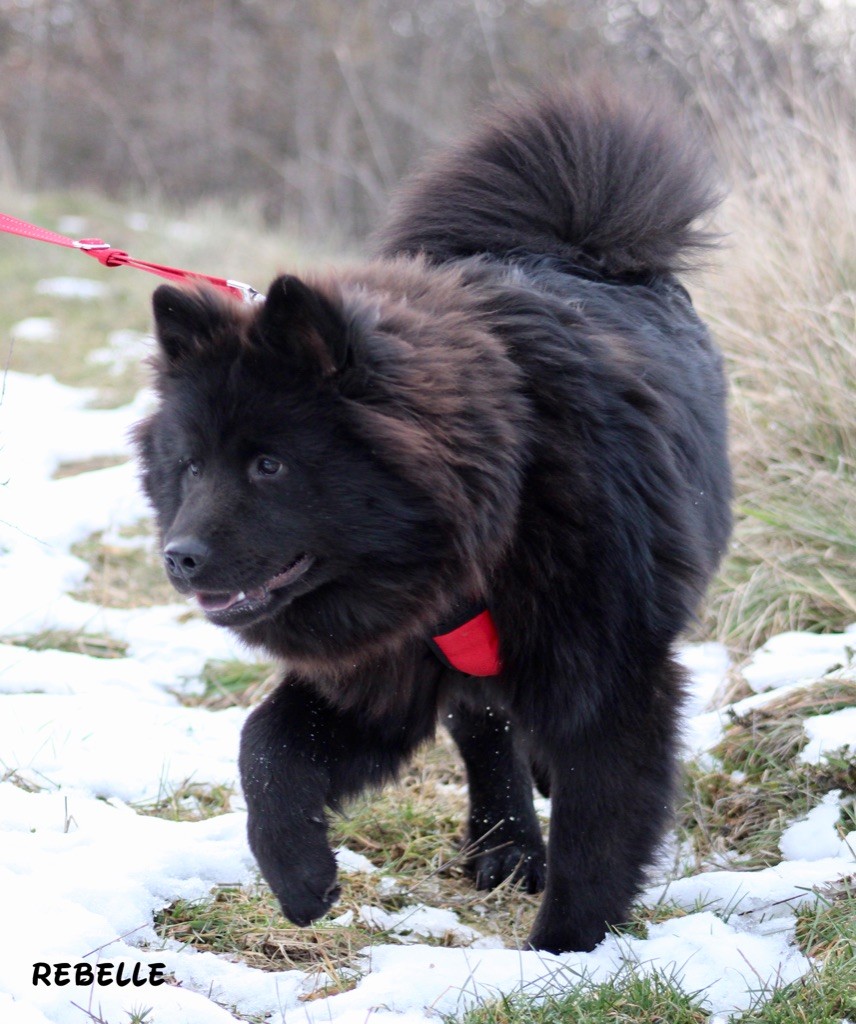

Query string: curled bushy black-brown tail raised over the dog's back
[378,85,719,276]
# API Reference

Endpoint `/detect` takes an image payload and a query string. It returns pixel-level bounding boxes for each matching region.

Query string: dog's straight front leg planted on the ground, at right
[529,659,680,952]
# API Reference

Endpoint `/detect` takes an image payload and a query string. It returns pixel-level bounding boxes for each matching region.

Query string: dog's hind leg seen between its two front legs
[441,696,546,893]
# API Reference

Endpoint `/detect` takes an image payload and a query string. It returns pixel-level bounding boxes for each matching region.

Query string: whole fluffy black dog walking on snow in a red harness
[137,83,730,950]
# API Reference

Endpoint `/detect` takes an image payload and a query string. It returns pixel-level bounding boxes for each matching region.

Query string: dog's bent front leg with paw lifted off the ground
[240,678,433,925]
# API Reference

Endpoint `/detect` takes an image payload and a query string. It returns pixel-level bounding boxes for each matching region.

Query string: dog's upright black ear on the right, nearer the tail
[259,274,350,377]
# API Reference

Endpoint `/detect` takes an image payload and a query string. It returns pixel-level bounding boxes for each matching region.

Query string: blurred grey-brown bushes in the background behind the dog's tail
[0,0,854,239]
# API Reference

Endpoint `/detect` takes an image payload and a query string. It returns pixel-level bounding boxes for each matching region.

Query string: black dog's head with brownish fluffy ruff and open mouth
[136,276,522,656]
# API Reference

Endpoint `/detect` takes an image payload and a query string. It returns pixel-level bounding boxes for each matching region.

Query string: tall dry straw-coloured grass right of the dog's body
[698,83,856,649]
